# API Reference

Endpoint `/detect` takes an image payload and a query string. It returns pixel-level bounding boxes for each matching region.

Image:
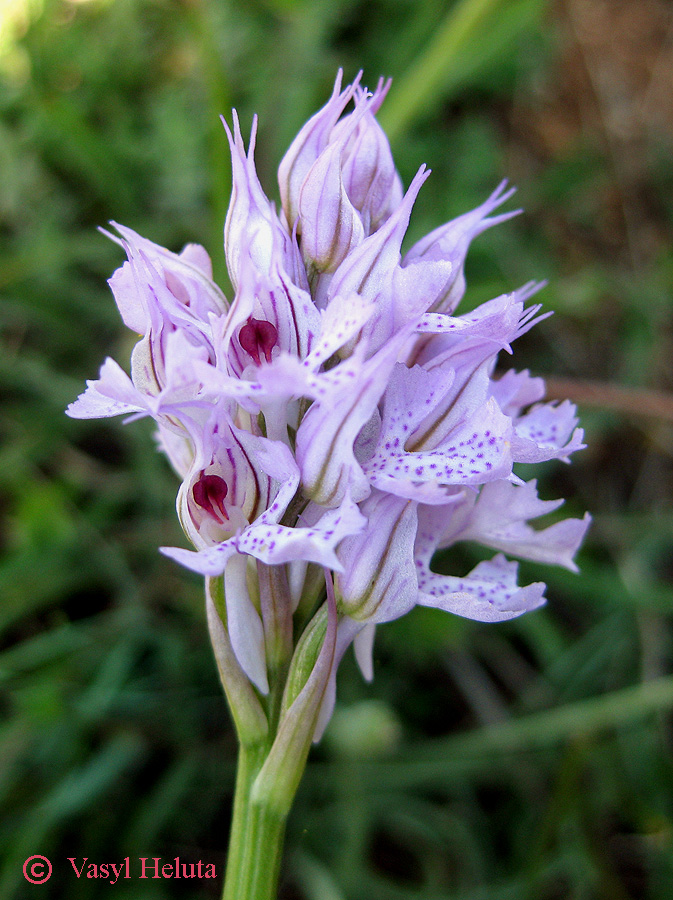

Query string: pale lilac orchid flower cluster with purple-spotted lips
[68,70,588,740]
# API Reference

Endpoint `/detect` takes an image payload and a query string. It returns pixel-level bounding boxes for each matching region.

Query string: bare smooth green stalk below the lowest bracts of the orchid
[222,743,285,900]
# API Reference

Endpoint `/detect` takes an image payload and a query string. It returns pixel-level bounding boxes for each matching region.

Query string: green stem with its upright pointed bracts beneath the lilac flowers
[218,579,330,900]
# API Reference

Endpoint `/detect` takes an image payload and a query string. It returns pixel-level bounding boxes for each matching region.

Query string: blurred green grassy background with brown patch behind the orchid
[0,0,673,900]
